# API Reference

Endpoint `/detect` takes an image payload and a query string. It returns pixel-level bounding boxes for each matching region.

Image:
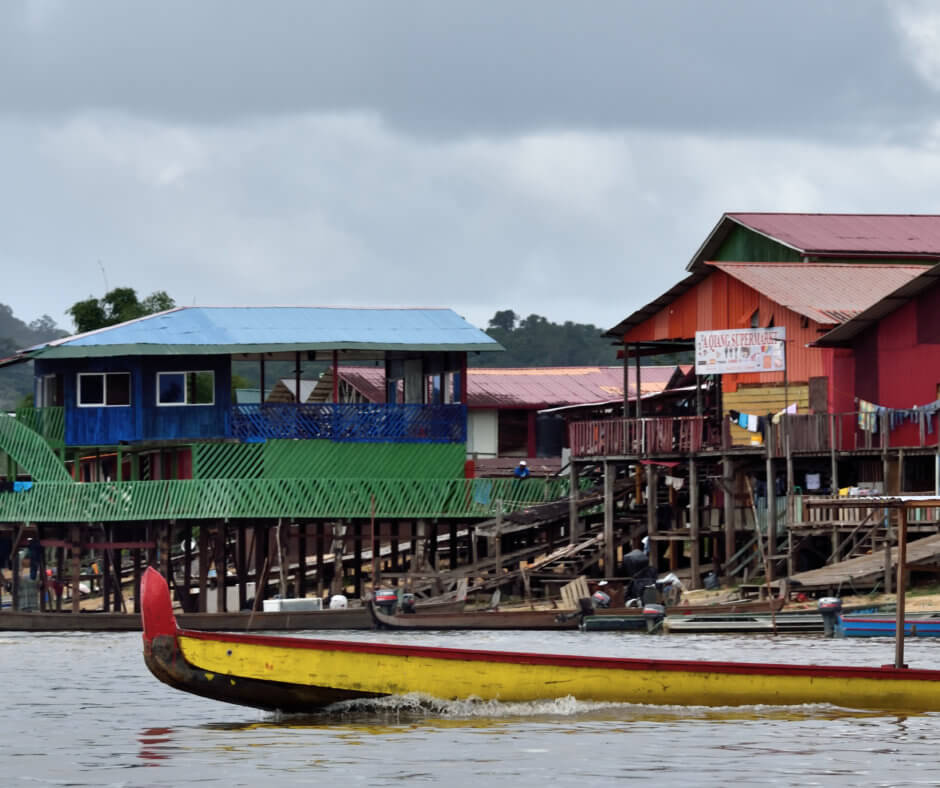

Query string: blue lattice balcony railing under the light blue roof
[232,403,467,443]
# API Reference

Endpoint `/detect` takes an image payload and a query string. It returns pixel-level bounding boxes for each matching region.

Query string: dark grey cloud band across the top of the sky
[0,0,937,139]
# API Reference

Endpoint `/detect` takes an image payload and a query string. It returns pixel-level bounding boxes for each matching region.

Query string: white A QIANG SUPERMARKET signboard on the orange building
[695,326,787,375]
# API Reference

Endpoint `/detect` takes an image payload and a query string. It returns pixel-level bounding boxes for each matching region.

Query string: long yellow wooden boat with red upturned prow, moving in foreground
[142,568,940,712]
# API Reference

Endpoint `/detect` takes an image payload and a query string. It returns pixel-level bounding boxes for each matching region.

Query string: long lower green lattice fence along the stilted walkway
[0,479,567,522]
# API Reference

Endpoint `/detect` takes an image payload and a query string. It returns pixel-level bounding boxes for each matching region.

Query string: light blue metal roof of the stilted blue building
[26,306,502,358]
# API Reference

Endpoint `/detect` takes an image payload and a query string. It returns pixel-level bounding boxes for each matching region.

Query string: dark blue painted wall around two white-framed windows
[35,356,232,446]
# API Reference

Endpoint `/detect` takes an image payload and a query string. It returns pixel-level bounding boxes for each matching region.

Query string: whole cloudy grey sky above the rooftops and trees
[0,0,940,330]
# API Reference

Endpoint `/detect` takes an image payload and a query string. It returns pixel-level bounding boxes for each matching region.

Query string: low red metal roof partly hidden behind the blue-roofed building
[324,365,676,410]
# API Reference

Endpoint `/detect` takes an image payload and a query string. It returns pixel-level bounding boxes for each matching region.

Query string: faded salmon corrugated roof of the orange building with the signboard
[709,262,930,325]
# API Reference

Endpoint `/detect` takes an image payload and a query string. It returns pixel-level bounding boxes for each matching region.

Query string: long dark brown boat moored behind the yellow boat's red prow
[0,601,465,632]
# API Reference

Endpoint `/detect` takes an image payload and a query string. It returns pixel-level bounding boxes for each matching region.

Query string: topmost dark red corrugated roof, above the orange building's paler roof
[726,213,940,256]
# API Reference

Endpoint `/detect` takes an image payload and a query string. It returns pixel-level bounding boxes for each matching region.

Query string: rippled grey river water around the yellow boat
[0,632,940,788]
